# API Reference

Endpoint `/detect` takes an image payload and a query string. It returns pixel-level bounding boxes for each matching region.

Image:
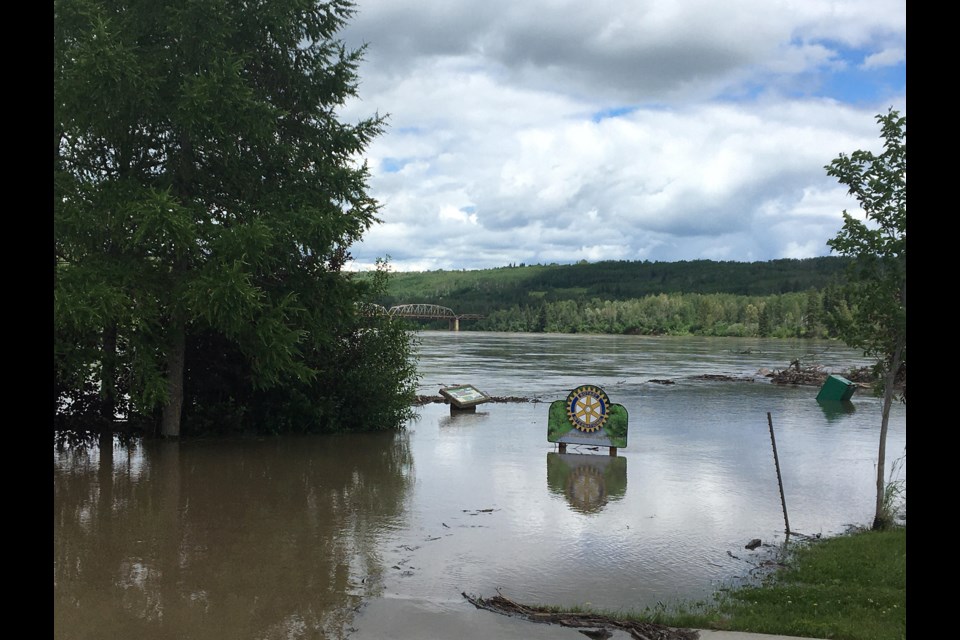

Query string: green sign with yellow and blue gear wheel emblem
[547,384,627,453]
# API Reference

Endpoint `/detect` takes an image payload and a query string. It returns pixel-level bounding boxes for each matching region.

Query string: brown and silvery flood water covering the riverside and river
[54,331,906,640]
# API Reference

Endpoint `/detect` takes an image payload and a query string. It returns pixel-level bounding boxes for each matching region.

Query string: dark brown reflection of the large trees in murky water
[54,433,412,639]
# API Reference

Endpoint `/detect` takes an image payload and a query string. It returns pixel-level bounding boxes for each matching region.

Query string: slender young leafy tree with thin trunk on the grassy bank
[825,109,907,529]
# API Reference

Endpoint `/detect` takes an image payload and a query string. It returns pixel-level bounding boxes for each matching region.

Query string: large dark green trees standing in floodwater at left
[53,0,412,436]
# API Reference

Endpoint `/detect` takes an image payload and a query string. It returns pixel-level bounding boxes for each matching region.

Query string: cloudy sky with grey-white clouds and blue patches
[340,0,906,271]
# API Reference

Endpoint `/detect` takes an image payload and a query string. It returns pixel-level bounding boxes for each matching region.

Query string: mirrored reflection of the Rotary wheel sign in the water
[547,452,627,514]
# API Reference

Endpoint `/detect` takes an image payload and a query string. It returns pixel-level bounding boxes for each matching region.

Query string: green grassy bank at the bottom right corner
[637,527,907,640]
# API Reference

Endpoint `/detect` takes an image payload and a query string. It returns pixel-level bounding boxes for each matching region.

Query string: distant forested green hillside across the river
[368,257,849,338]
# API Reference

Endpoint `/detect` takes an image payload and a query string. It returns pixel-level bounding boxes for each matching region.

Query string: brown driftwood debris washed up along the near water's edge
[462,591,700,640]
